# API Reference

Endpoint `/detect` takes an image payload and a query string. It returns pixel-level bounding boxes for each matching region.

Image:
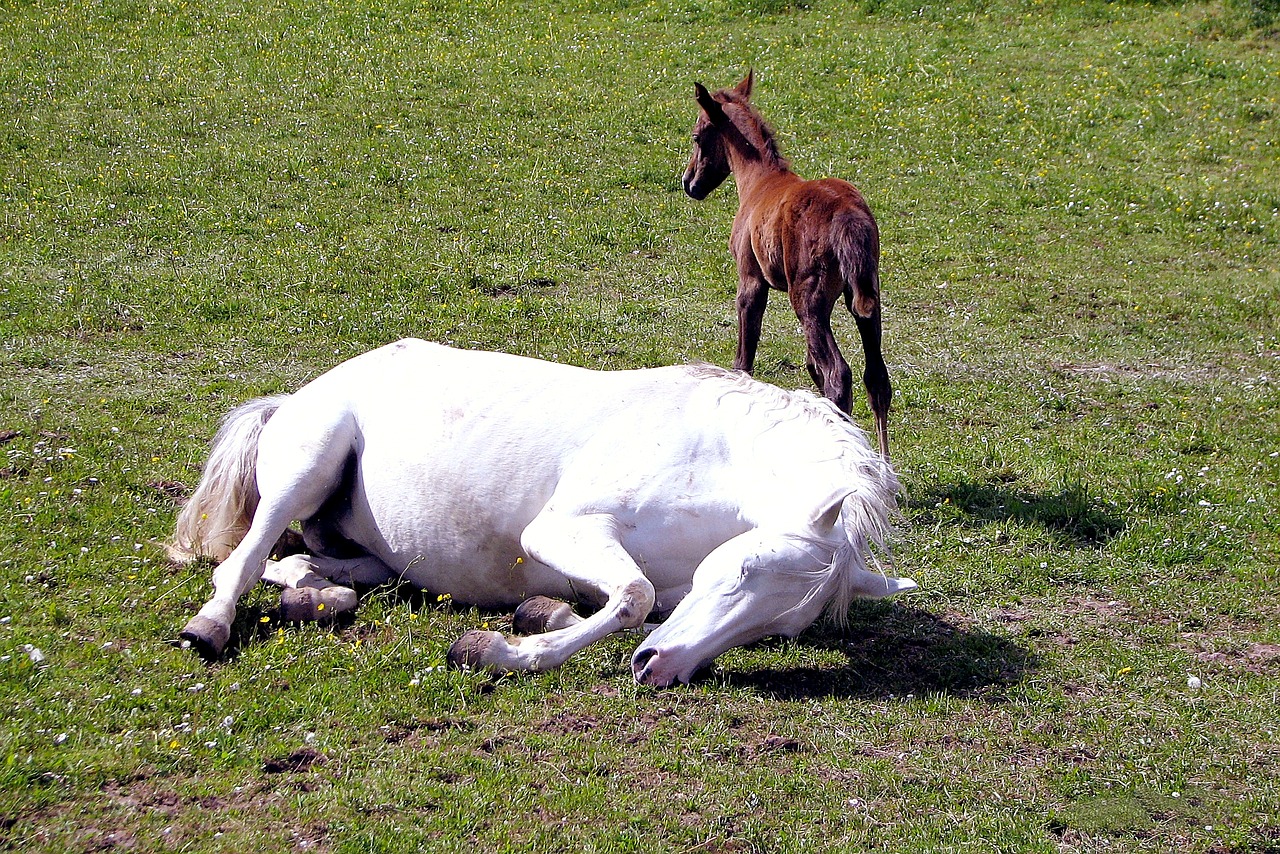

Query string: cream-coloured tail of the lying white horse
[166,394,287,563]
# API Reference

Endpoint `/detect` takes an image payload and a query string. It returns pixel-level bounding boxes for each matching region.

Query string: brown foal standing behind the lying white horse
[684,72,893,457]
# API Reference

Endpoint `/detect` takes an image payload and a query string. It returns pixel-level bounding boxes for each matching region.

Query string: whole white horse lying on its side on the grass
[170,339,915,686]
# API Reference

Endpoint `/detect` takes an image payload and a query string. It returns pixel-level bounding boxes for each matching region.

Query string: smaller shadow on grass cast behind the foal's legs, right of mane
[905,480,1128,547]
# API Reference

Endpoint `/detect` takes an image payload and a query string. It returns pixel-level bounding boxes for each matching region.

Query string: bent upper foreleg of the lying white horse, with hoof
[449,511,654,671]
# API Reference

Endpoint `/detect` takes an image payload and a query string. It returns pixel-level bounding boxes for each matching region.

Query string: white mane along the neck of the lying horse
[689,362,899,625]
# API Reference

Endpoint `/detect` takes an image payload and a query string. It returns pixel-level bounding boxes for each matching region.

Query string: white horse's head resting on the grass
[631,501,915,688]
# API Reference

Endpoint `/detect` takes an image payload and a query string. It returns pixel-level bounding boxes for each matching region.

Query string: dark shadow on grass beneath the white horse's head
[719,602,1038,700]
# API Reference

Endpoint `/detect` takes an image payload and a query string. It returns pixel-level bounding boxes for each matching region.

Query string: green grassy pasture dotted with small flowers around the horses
[0,0,1280,854]
